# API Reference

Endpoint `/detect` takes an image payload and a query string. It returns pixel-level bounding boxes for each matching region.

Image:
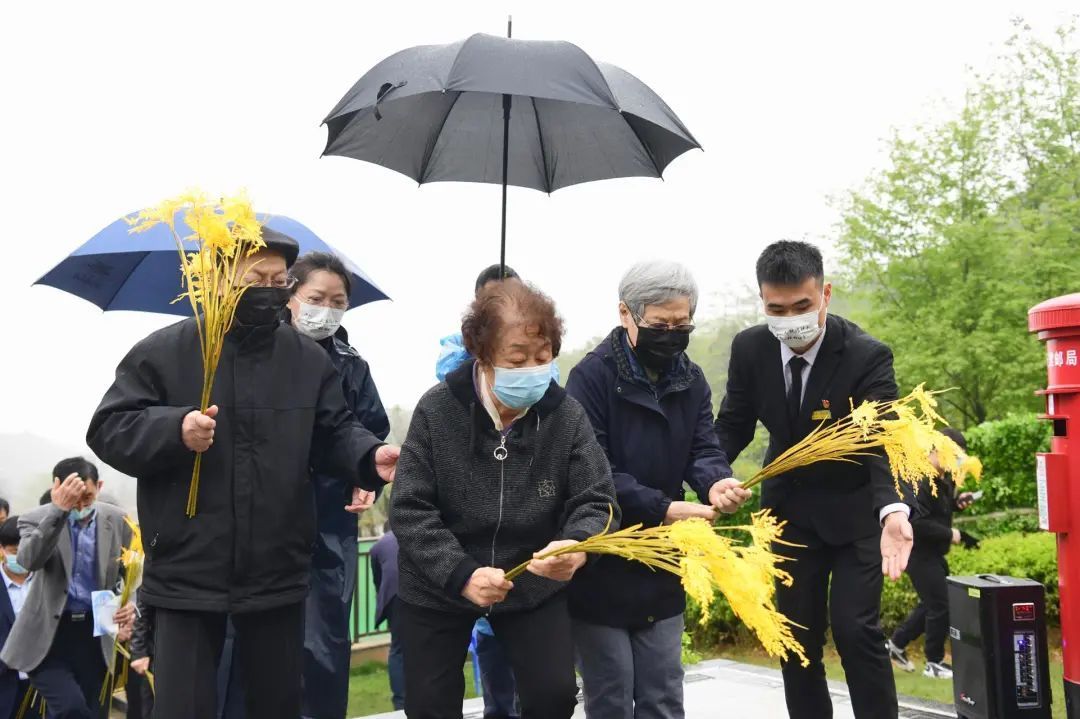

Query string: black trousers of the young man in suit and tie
[774,525,897,719]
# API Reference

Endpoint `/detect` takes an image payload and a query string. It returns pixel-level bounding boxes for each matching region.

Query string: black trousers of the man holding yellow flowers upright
[153,602,303,719]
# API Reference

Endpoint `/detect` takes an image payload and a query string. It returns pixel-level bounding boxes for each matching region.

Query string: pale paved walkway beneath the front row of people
[358,660,956,719]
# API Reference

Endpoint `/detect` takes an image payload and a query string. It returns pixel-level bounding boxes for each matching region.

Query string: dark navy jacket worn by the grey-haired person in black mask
[566,327,731,628]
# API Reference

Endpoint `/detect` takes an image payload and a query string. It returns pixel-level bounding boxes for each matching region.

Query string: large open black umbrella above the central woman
[323,20,701,272]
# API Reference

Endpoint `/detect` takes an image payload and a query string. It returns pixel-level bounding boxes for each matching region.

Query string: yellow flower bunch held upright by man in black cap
[126,190,266,517]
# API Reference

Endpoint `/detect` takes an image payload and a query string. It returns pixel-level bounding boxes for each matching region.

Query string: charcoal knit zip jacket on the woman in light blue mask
[390,362,619,612]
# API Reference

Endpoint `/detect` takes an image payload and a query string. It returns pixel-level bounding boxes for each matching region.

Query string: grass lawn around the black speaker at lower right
[716,632,1065,719]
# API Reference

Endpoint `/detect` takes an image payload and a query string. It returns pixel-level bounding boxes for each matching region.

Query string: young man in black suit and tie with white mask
[716,241,912,719]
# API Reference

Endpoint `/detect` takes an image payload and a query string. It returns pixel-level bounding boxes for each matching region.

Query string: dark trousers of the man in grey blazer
[30,612,108,719]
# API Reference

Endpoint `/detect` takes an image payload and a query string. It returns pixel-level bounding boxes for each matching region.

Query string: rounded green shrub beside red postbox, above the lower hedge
[964,415,1052,514]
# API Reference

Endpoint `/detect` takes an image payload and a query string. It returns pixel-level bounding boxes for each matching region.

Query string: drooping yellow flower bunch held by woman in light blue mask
[507,511,807,665]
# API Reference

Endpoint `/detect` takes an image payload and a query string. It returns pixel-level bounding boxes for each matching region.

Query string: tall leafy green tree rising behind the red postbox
[838,25,1080,426]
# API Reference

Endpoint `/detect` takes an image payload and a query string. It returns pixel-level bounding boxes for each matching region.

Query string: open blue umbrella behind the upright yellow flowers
[33,215,390,316]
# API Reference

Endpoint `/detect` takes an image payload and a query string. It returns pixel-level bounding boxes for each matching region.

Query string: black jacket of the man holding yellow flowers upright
[86,318,381,612]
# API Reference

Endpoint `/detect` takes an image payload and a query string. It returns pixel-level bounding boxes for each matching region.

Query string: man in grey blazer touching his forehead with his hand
[0,457,135,719]
